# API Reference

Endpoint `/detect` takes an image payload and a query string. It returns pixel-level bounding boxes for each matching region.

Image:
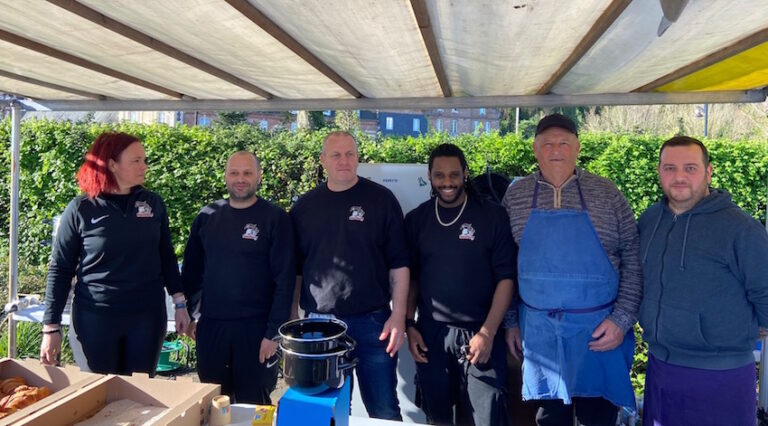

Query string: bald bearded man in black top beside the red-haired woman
[181,151,296,404]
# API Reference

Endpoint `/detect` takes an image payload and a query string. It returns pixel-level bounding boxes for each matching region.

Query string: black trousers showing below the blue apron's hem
[536,397,619,426]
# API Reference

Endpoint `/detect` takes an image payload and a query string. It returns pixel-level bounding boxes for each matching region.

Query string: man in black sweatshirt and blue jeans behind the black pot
[290,132,409,420]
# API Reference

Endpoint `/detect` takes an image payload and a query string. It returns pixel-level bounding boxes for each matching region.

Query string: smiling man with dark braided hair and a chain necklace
[405,144,517,425]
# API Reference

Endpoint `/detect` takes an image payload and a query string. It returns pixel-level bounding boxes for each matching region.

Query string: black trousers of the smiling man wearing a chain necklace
[416,320,509,426]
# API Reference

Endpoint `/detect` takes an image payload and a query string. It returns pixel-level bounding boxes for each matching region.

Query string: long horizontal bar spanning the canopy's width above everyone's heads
[7,89,768,111]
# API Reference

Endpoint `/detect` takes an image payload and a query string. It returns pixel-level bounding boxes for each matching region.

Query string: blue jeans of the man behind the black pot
[338,309,403,421]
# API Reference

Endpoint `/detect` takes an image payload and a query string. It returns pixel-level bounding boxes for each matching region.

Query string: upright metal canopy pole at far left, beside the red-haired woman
[8,101,22,358]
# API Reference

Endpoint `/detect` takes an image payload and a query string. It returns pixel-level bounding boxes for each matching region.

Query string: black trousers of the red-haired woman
[72,302,167,376]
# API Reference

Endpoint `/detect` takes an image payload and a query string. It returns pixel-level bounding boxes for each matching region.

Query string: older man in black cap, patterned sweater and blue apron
[503,114,642,426]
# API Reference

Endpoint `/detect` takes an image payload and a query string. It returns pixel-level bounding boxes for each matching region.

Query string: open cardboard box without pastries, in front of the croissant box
[18,374,221,426]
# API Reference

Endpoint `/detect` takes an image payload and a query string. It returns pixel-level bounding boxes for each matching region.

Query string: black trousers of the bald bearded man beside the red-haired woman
[197,317,277,404]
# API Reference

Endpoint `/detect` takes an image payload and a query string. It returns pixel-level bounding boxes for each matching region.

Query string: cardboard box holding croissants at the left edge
[0,358,103,425]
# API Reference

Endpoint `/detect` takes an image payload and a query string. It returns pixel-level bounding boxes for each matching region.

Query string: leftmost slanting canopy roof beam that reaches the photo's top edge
[48,0,275,99]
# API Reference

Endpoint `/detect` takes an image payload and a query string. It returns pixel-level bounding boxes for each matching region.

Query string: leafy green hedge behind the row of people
[0,120,768,265]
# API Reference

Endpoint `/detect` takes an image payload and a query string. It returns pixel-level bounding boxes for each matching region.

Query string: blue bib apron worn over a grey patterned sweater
[517,181,635,409]
